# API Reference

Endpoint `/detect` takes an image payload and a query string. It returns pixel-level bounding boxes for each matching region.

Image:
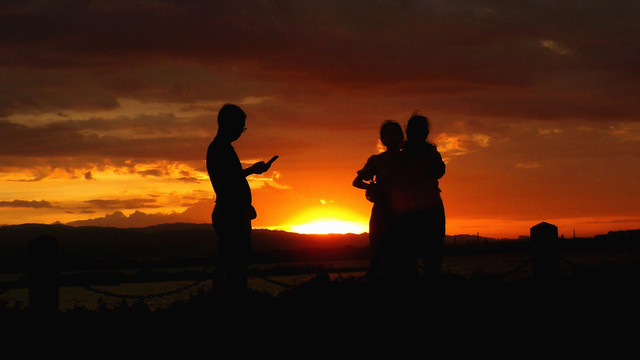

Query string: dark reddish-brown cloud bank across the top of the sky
[0,0,640,119]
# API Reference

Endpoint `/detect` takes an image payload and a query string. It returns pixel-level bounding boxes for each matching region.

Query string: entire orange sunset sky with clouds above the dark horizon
[0,0,640,237]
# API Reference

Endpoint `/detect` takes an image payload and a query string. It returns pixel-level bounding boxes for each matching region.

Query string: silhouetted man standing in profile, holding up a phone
[207,104,275,295]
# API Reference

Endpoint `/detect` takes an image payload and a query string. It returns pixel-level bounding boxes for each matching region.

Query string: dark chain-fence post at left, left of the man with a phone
[27,235,59,314]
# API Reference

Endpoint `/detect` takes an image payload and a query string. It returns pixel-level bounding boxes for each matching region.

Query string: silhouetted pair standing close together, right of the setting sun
[353,114,445,288]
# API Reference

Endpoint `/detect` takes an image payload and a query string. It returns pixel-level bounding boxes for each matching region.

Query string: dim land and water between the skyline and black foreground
[0,224,640,311]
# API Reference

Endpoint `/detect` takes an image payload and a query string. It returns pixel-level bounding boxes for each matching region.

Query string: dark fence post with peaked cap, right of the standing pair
[530,222,560,283]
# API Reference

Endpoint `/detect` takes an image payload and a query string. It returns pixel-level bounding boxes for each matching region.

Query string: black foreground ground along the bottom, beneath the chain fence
[0,263,640,359]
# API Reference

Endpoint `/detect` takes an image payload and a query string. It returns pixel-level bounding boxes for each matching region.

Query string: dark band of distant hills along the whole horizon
[0,223,640,272]
